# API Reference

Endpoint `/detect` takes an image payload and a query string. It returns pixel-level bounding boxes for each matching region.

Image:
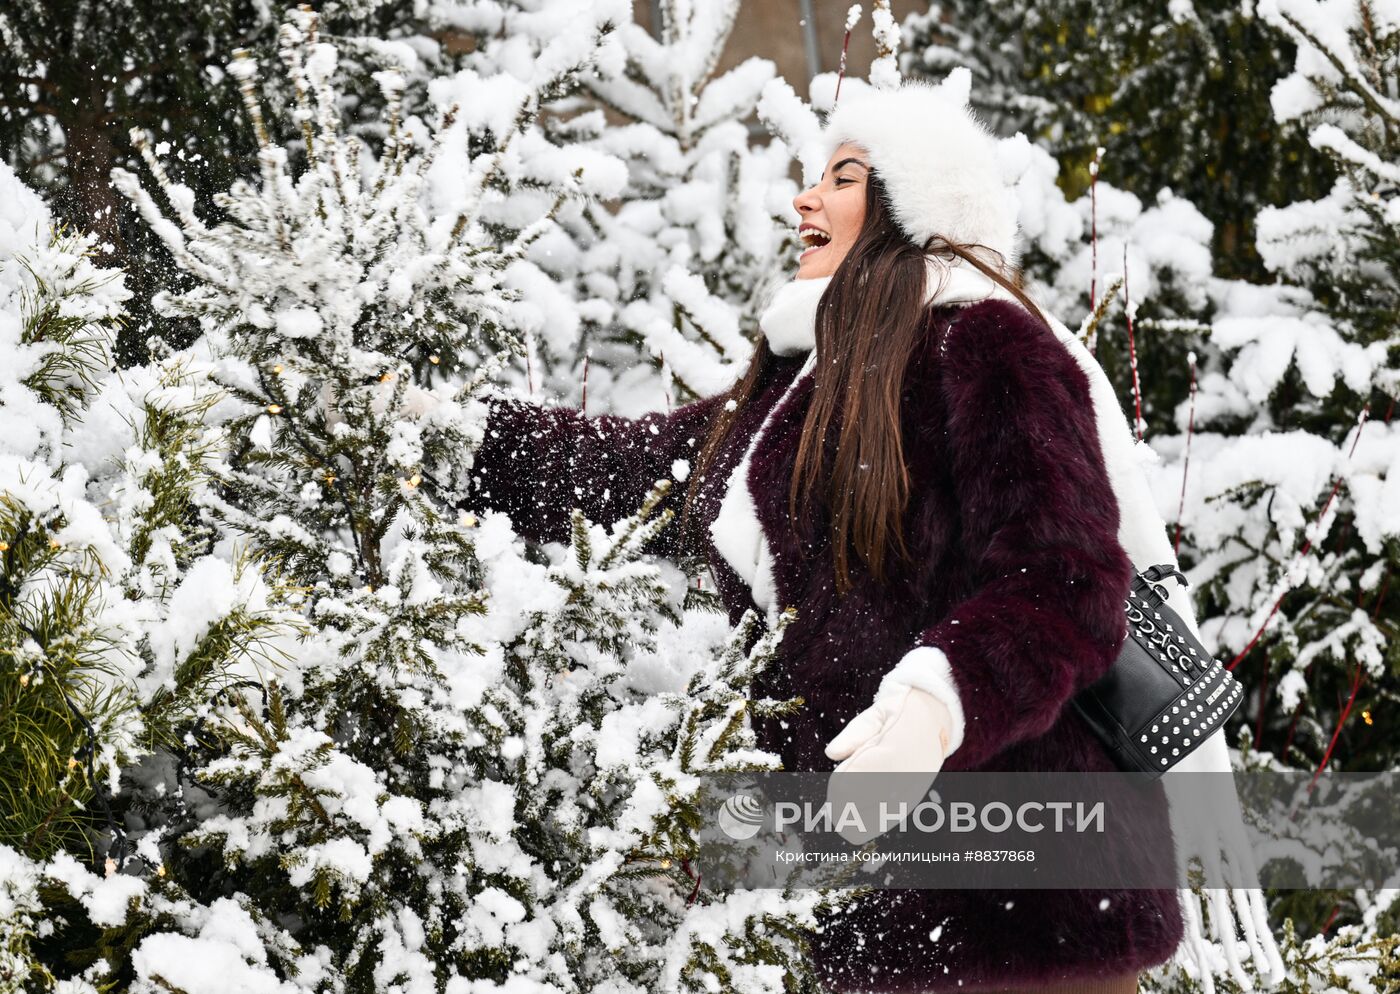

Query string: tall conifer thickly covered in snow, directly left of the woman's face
[582,0,797,409]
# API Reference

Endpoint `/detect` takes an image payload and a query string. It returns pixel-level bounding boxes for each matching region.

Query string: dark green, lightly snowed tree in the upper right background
[903,0,1333,279]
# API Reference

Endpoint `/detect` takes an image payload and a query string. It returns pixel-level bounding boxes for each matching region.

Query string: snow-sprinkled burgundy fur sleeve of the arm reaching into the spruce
[469,395,722,556]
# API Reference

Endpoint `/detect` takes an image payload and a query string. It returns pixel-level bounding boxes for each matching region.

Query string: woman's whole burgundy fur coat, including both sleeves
[473,300,1183,994]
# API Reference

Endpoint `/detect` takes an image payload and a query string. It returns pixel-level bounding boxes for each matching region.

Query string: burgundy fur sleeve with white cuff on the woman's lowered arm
[878,301,1133,769]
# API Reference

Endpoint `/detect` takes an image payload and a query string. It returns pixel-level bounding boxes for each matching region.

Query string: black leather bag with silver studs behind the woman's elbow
[1072,566,1245,778]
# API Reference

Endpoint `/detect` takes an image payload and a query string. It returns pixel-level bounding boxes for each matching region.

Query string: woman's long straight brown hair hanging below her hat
[680,169,1043,596]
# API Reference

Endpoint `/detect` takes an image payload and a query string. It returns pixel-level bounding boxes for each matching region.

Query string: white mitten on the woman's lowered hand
[826,686,953,846]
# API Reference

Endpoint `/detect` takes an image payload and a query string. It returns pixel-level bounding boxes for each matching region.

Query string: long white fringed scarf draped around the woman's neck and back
[710,259,1285,994]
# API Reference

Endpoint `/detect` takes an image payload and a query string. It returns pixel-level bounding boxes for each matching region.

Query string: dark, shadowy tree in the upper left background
[0,0,482,365]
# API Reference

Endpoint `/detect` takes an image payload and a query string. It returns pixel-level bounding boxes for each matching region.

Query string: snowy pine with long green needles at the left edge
[0,165,137,857]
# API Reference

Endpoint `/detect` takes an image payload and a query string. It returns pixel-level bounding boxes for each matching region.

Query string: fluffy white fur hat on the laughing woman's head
[822,66,1019,266]
